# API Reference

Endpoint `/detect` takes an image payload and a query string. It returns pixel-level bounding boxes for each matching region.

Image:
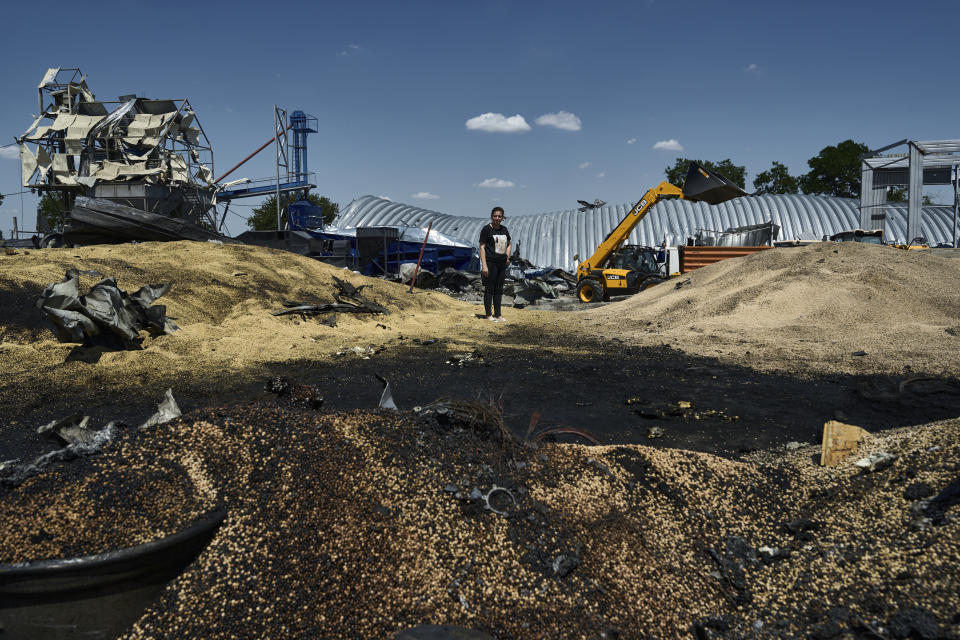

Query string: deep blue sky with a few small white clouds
[0,0,960,237]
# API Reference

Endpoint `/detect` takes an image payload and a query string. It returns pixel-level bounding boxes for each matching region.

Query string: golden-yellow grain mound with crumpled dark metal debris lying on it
[0,242,473,370]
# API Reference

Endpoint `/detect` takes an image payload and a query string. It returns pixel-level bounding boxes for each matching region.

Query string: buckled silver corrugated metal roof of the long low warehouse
[334,195,953,271]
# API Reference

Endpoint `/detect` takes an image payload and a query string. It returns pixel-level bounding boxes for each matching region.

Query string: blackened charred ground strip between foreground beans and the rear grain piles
[0,326,960,459]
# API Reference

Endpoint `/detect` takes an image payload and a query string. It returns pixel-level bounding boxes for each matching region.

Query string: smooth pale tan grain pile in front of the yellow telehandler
[580,242,960,375]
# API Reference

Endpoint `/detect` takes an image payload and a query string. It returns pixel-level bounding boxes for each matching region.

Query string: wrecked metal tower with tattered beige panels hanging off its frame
[17,68,216,235]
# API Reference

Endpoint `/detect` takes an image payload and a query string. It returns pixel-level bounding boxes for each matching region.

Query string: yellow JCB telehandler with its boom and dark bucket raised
[573,162,748,302]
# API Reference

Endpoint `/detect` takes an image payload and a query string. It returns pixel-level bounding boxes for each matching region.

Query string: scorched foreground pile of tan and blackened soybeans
[0,392,960,639]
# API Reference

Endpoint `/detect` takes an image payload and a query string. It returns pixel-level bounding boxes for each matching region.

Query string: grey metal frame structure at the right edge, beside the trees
[860,140,960,247]
